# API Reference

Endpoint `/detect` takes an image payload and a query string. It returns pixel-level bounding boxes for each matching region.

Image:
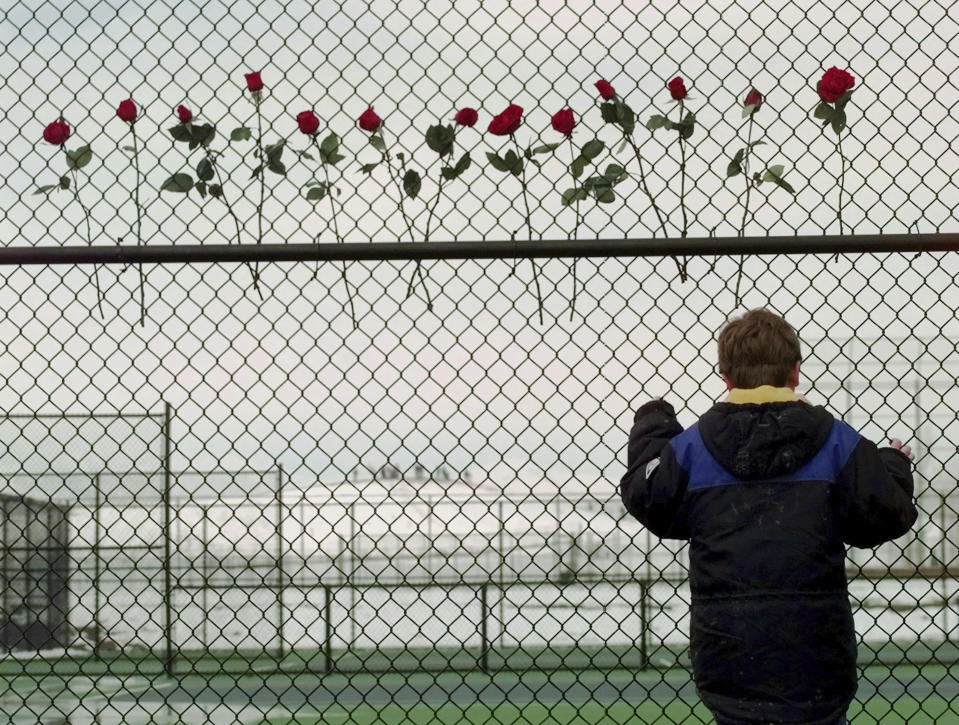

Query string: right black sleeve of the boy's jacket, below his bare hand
[836,437,918,549]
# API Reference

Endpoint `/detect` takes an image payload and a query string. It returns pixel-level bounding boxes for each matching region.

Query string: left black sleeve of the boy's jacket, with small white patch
[619,400,689,539]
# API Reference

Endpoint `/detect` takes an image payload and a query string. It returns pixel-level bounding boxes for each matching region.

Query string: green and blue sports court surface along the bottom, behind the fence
[0,663,959,725]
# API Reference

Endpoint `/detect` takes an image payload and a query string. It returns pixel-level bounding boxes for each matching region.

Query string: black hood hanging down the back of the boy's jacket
[699,402,834,480]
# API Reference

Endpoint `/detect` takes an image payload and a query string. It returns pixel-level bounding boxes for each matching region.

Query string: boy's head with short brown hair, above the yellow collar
[719,310,802,388]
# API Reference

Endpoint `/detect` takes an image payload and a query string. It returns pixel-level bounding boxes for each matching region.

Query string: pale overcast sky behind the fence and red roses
[0,0,959,520]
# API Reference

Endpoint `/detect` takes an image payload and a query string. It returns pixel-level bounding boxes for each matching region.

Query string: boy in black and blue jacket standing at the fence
[620,310,917,725]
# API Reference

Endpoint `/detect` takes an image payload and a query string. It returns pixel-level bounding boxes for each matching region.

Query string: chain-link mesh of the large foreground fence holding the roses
[0,0,959,725]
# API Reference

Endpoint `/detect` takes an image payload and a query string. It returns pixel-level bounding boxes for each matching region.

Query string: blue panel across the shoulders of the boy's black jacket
[669,420,860,491]
